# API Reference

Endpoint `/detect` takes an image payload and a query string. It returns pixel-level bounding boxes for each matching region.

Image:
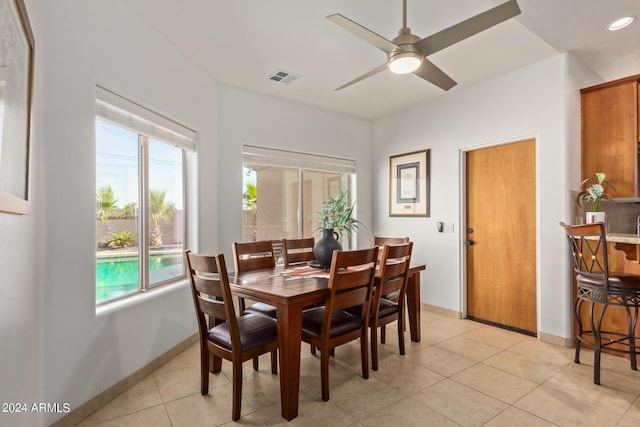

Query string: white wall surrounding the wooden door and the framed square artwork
[374,55,594,338]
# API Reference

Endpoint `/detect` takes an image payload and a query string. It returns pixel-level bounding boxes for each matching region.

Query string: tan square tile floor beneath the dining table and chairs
[72,311,640,427]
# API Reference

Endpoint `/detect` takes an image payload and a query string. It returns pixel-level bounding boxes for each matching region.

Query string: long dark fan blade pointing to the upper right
[415,0,520,56]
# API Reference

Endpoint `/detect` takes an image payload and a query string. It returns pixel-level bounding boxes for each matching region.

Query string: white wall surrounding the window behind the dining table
[218,84,374,263]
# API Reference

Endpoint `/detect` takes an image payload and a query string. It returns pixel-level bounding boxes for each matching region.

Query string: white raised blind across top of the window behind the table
[242,145,356,174]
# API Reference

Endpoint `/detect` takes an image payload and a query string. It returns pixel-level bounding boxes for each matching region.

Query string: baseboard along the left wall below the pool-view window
[51,333,199,427]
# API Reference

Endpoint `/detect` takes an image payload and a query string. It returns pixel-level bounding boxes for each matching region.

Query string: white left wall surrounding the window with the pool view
[32,0,217,422]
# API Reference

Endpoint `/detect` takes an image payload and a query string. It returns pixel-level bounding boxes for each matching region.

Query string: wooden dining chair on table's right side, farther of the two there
[345,242,413,371]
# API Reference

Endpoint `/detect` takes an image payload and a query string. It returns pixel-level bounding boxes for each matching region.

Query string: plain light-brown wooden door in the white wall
[466,139,537,334]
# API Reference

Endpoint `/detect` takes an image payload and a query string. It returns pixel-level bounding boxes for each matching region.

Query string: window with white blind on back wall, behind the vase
[242,145,355,249]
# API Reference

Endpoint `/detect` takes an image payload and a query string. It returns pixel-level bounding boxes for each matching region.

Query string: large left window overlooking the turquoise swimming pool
[95,87,195,304]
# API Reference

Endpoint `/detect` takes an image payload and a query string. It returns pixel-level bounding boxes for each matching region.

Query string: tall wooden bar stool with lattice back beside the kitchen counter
[560,222,640,384]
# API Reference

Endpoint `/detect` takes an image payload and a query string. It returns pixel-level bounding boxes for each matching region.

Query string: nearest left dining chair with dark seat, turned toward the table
[185,251,278,421]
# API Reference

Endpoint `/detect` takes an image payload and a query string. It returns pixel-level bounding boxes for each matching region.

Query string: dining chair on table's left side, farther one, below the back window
[232,240,276,319]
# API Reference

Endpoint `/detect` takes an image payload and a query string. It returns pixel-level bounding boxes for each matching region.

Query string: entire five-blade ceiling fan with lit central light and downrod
[327,0,520,90]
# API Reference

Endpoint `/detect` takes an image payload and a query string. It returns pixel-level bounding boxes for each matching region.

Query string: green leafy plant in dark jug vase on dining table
[313,190,362,268]
